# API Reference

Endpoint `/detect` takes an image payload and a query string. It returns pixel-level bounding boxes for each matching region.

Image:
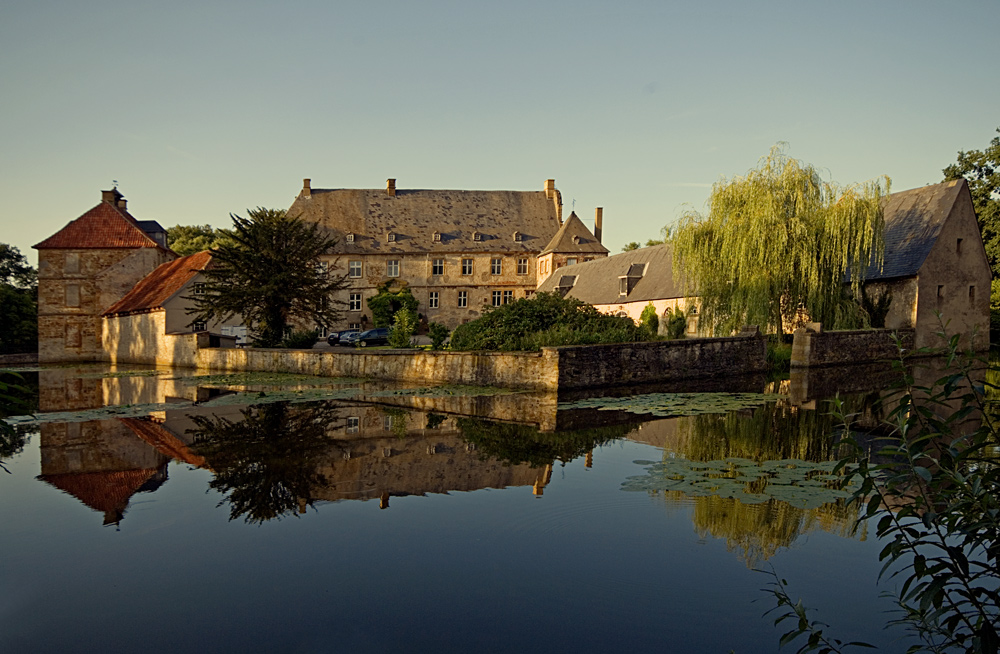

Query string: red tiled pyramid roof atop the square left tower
[33,202,170,250]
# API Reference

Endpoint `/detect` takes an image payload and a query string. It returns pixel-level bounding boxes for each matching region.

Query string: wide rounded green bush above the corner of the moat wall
[451,293,642,351]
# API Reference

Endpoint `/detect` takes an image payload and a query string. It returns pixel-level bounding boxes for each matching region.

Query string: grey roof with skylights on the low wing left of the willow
[538,245,684,304]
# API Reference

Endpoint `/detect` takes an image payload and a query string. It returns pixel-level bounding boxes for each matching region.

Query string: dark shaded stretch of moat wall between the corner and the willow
[554,331,767,389]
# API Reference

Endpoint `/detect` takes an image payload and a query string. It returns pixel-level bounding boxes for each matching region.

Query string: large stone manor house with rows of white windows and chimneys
[288,179,608,330]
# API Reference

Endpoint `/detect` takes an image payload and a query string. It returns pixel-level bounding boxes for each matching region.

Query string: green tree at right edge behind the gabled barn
[941,128,1000,277]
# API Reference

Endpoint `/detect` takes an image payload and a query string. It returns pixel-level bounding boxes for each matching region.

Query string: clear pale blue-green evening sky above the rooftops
[0,0,1000,263]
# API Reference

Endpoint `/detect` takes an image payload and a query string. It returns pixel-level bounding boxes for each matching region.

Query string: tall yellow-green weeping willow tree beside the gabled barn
[672,146,889,334]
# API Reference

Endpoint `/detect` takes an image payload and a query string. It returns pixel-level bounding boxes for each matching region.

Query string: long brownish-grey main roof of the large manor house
[288,189,561,254]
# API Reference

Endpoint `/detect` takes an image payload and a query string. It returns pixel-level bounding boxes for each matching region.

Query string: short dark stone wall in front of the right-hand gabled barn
[792,325,914,368]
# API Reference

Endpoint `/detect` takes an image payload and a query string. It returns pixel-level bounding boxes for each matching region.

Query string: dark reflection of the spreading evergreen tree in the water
[190,402,348,523]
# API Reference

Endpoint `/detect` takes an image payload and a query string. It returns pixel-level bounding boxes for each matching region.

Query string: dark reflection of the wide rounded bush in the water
[458,418,632,467]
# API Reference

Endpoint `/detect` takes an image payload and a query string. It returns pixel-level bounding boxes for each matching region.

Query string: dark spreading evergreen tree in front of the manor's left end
[188,208,345,347]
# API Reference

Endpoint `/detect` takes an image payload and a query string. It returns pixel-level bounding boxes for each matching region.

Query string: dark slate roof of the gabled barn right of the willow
[866,179,968,280]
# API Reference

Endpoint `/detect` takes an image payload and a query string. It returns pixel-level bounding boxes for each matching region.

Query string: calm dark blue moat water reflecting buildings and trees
[0,367,920,653]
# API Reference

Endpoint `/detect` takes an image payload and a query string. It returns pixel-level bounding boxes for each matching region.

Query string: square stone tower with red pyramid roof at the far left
[34,189,177,362]
